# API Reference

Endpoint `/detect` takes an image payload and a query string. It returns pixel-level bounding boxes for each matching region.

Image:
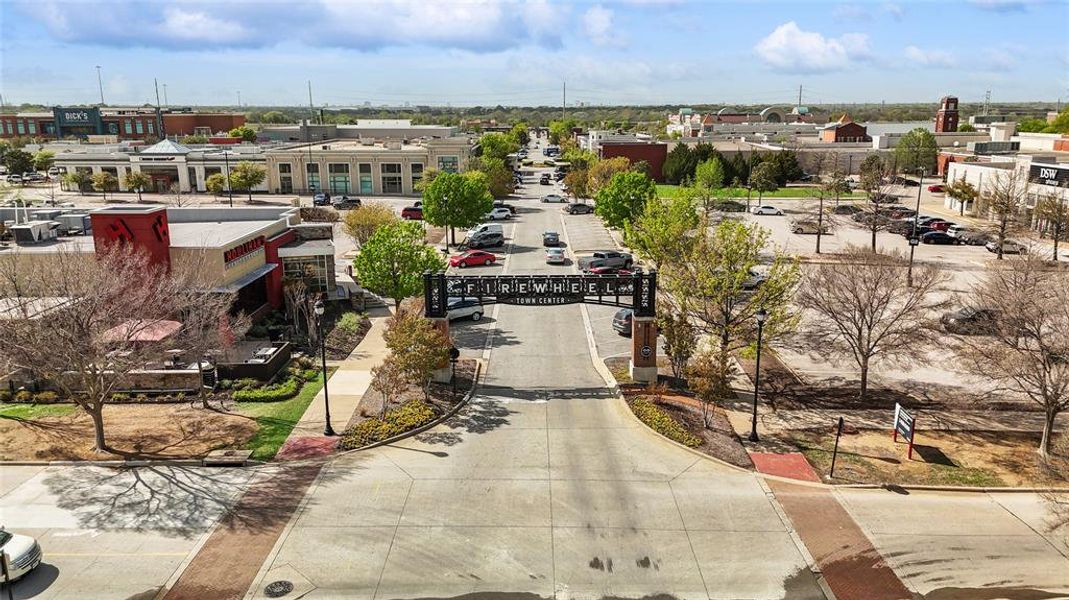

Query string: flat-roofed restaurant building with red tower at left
[0,205,337,318]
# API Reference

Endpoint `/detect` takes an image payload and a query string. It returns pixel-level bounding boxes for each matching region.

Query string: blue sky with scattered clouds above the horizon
[0,0,1069,105]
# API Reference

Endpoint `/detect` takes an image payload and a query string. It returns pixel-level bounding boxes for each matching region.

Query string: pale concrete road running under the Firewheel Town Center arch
[253,139,824,598]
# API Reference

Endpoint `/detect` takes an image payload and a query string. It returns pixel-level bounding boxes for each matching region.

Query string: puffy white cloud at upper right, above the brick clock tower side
[754,21,869,73]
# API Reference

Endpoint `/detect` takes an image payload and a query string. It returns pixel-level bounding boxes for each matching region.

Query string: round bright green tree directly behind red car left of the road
[423,171,494,244]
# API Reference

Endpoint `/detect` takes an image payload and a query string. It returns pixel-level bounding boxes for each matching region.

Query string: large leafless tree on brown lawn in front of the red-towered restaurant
[0,244,238,451]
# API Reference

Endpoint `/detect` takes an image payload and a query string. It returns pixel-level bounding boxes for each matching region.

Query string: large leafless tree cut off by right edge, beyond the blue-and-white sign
[951,258,1069,458]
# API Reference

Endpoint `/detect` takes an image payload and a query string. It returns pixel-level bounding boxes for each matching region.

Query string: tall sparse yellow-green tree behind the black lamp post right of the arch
[660,220,801,389]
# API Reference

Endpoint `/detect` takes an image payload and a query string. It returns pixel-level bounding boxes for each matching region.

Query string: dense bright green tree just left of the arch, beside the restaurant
[353,220,446,308]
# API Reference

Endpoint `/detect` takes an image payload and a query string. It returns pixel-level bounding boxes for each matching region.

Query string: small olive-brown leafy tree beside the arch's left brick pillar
[383,310,450,399]
